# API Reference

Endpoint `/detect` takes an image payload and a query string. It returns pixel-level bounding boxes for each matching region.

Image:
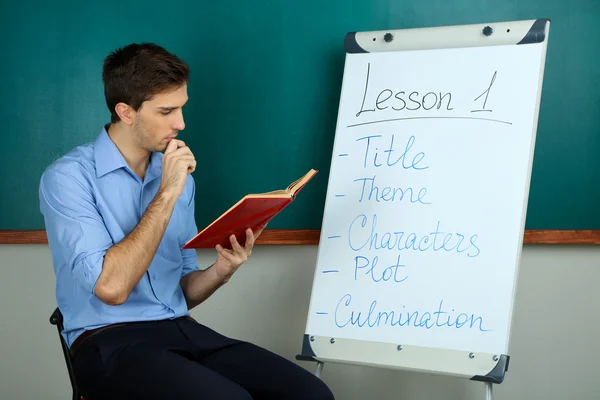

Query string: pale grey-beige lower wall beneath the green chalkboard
[0,245,600,400]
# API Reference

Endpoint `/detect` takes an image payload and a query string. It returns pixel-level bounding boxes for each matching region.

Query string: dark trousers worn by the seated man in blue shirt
[73,318,334,400]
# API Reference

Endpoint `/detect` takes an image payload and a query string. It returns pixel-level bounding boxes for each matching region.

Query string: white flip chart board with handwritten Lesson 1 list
[302,20,549,382]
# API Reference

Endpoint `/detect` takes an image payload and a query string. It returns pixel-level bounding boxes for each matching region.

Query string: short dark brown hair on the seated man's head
[102,43,190,123]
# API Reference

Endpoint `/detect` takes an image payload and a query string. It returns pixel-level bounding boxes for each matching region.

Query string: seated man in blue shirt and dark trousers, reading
[39,44,333,400]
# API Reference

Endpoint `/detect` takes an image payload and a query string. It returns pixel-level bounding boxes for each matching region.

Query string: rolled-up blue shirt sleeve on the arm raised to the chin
[39,169,113,293]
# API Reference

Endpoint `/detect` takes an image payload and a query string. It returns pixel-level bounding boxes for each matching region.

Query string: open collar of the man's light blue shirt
[94,125,163,181]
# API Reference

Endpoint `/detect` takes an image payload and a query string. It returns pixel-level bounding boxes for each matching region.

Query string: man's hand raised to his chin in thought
[159,139,196,199]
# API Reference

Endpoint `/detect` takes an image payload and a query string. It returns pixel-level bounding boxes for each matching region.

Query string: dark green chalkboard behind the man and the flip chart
[0,0,600,230]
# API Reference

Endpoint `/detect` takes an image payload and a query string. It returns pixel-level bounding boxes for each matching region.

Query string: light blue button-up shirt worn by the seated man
[39,126,199,347]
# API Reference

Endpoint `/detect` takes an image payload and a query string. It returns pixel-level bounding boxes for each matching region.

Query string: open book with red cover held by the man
[183,169,318,249]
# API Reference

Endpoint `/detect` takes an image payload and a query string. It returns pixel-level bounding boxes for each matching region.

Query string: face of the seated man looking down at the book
[133,85,188,151]
